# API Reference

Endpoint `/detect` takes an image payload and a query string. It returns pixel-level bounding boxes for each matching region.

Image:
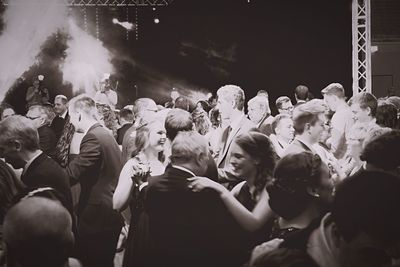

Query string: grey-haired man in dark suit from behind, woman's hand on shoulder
[145,131,239,266]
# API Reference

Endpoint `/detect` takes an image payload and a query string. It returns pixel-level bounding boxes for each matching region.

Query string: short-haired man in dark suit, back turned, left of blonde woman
[66,95,123,267]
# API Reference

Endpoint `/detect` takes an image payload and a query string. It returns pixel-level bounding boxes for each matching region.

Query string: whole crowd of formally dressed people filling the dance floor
[0,82,400,267]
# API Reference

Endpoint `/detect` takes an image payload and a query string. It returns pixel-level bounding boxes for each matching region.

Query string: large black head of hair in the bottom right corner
[332,171,400,245]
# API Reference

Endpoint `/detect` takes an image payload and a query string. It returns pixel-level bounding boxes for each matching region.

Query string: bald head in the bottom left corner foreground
[3,197,74,267]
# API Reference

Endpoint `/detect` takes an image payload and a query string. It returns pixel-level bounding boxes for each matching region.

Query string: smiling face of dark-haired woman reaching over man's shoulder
[230,142,257,180]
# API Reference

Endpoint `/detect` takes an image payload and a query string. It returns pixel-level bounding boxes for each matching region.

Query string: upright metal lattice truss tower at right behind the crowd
[352,0,372,95]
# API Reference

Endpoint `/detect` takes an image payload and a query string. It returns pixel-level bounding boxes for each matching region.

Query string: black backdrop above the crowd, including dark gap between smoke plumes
[5,0,352,114]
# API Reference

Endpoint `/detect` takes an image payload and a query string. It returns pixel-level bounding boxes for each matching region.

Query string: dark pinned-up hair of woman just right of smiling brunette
[267,152,323,220]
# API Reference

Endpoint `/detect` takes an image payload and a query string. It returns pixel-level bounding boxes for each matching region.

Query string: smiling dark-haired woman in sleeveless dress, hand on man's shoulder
[190,131,277,232]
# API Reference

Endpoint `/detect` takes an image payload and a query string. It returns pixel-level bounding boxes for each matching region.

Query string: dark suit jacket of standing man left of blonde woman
[67,123,123,234]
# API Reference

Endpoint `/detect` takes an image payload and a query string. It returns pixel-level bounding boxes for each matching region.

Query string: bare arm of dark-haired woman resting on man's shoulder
[189,177,274,231]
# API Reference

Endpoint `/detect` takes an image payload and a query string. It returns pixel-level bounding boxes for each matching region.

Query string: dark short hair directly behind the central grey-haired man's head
[164,108,193,141]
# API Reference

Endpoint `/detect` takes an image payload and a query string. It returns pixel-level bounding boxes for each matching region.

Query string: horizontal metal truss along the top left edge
[0,0,173,6]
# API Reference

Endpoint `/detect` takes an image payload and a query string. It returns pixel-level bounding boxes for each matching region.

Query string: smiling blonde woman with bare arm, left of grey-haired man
[113,120,166,266]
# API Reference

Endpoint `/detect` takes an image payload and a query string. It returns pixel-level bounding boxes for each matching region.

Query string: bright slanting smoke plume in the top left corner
[0,0,67,100]
